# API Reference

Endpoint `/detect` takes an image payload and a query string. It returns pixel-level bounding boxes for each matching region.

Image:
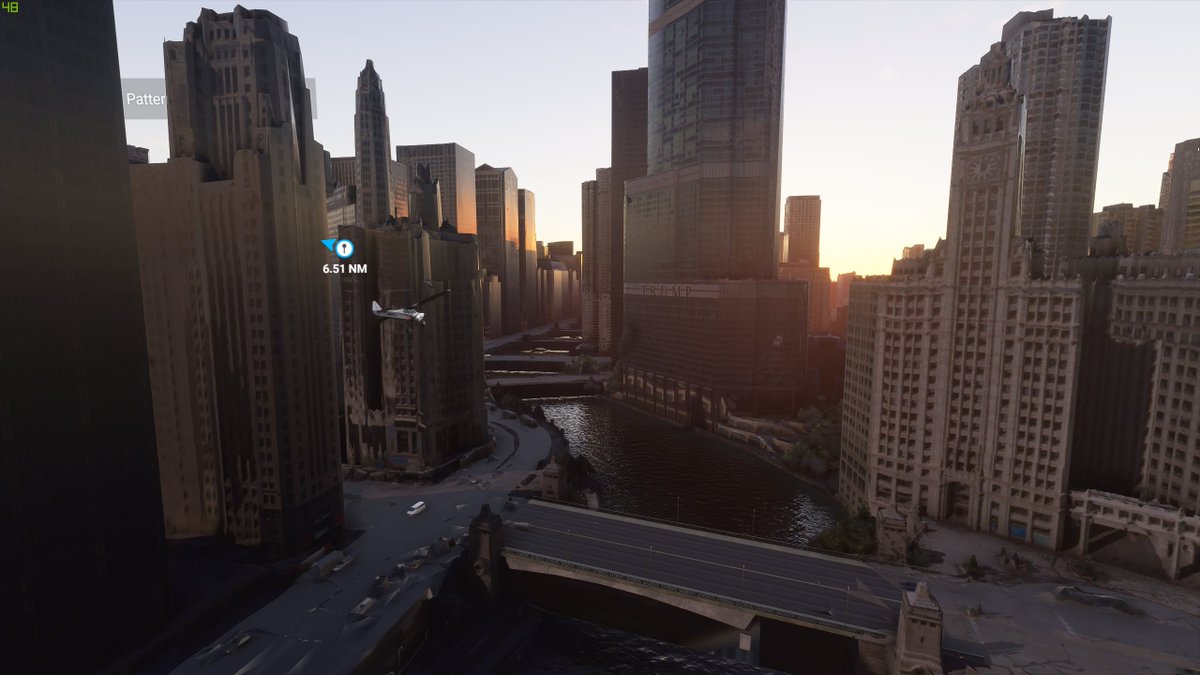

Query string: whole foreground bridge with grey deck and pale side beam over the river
[465,501,940,673]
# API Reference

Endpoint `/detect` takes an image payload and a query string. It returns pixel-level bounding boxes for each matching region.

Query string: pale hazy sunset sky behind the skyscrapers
[115,0,1200,274]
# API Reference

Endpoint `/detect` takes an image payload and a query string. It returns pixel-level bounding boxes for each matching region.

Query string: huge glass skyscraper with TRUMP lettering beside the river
[619,0,806,420]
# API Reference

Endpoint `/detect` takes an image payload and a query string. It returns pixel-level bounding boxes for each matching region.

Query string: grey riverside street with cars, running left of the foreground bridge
[173,403,550,675]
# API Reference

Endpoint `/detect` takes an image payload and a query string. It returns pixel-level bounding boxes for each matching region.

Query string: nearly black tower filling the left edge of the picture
[0,2,168,673]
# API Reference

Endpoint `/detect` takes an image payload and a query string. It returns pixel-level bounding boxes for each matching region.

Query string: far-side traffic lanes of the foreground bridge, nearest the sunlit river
[512,502,900,607]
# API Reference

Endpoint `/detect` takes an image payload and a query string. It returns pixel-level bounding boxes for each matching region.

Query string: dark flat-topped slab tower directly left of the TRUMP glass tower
[614,68,649,354]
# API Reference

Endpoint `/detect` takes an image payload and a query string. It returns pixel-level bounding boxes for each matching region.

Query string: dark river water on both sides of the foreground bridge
[520,398,833,675]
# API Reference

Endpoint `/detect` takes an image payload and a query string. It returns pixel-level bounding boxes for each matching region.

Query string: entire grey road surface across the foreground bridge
[504,501,900,633]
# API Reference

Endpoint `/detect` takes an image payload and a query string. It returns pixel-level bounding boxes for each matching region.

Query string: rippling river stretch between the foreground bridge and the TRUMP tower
[535,398,833,544]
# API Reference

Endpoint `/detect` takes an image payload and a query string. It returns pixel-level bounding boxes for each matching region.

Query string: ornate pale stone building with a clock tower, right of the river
[839,24,1106,548]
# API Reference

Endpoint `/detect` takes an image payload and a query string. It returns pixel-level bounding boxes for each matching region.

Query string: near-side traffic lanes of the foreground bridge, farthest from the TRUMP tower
[506,516,896,629]
